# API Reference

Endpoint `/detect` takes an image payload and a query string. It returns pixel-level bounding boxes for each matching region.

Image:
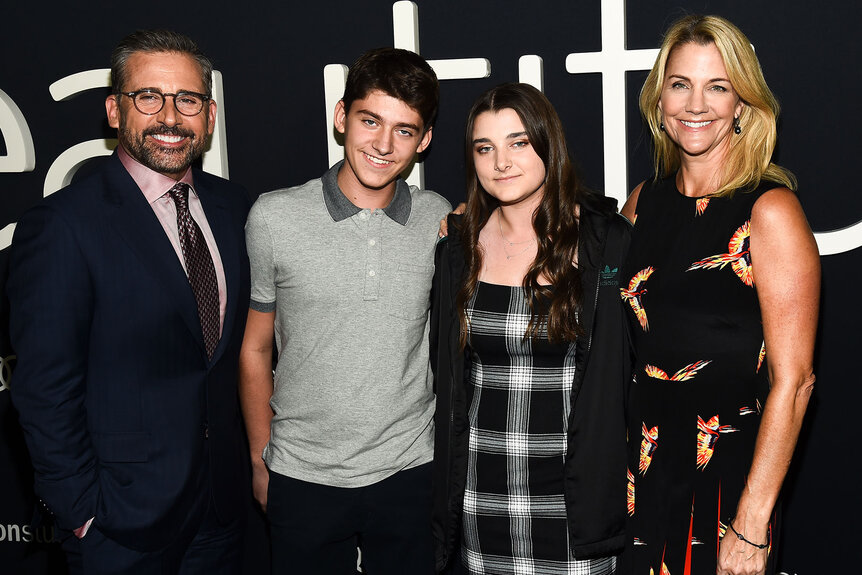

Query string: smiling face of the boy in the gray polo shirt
[335,90,431,204]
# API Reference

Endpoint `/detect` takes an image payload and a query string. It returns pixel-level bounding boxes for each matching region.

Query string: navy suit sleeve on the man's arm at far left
[7,205,98,529]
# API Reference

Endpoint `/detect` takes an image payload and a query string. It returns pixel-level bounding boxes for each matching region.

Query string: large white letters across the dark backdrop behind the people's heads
[0,0,862,256]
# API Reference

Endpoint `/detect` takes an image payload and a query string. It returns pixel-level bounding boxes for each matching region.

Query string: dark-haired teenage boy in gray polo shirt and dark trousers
[240,48,450,575]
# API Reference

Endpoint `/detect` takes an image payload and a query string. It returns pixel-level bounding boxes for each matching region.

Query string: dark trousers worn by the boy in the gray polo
[266,463,434,575]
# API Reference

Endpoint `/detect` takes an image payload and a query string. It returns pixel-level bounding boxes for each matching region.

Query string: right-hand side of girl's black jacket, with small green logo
[565,210,631,559]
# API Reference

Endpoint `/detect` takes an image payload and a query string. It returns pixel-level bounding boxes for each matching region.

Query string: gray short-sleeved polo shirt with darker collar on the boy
[246,163,451,487]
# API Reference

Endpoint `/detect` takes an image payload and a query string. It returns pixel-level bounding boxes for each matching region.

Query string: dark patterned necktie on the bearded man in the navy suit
[168,182,219,359]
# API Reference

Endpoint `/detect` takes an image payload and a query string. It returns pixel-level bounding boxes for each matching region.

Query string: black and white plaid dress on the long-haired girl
[462,282,622,575]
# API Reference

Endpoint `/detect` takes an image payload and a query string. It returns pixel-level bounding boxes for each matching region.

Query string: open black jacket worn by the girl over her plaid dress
[430,194,632,571]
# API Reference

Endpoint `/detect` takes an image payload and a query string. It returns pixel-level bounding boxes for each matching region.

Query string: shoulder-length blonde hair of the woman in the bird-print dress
[640,15,796,195]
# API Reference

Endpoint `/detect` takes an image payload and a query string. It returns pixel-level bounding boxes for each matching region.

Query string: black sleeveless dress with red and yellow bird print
[620,176,776,575]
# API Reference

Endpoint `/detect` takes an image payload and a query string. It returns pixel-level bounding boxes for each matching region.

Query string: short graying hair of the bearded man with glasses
[111,30,213,97]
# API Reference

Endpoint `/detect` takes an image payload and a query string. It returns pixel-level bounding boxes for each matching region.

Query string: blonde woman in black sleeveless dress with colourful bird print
[620,16,820,575]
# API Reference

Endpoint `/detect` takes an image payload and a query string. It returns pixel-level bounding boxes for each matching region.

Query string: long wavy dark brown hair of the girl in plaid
[456,83,582,347]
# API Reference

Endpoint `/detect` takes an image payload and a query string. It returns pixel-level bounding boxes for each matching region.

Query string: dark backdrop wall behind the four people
[0,0,862,575]
